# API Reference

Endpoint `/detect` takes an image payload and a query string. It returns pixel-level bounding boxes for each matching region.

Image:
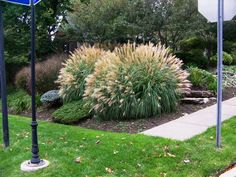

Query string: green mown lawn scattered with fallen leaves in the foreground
[0,116,236,177]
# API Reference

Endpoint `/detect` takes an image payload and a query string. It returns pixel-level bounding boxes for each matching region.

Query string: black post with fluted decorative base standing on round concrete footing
[31,0,40,164]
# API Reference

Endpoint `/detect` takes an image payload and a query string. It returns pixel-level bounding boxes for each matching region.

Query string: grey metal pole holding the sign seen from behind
[216,0,224,148]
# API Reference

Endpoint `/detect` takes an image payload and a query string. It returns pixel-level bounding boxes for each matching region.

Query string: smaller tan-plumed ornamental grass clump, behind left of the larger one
[57,46,105,103]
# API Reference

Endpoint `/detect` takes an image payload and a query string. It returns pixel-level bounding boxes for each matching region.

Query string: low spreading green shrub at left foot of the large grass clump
[52,100,91,124]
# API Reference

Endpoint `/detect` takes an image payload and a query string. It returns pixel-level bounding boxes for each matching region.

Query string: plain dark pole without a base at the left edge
[0,2,9,147]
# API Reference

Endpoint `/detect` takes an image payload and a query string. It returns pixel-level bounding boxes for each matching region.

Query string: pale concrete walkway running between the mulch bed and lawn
[142,97,236,141]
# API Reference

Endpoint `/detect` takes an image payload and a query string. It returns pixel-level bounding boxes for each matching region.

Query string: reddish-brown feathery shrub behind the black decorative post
[15,55,66,94]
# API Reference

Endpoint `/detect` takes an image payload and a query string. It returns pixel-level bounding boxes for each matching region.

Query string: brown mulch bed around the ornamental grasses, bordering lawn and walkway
[18,88,236,133]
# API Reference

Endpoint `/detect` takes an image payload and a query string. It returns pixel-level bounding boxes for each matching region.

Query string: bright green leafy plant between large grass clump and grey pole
[188,67,217,93]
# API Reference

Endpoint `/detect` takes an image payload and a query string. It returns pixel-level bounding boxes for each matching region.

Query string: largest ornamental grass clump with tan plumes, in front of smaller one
[84,43,191,119]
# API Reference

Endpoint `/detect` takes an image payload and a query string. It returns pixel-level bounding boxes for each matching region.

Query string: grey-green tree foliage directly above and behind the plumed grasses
[63,0,199,49]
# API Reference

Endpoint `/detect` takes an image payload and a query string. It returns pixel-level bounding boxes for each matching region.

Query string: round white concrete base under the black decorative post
[20,160,49,172]
